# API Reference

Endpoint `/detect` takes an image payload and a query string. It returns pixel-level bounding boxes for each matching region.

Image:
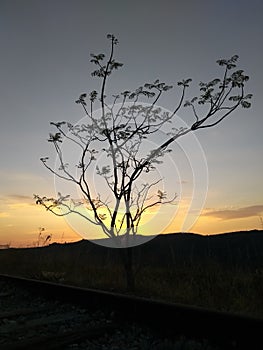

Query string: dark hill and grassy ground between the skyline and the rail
[0,230,263,318]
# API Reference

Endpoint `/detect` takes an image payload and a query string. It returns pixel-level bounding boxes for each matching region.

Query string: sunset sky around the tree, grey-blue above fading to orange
[0,0,263,246]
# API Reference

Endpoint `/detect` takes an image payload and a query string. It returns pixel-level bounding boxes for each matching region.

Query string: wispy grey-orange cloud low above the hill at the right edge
[202,205,263,220]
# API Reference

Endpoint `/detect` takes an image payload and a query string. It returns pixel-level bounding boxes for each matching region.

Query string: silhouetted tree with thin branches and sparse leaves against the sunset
[34,34,252,288]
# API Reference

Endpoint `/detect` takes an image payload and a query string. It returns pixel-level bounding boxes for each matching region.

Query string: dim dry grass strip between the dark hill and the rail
[0,243,263,318]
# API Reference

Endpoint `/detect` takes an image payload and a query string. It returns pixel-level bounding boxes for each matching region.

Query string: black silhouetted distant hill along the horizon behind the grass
[0,230,263,272]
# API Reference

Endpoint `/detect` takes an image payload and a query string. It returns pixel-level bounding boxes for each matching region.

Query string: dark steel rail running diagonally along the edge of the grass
[0,274,263,350]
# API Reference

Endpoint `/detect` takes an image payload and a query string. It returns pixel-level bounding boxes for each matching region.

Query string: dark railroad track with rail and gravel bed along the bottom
[0,275,263,350]
